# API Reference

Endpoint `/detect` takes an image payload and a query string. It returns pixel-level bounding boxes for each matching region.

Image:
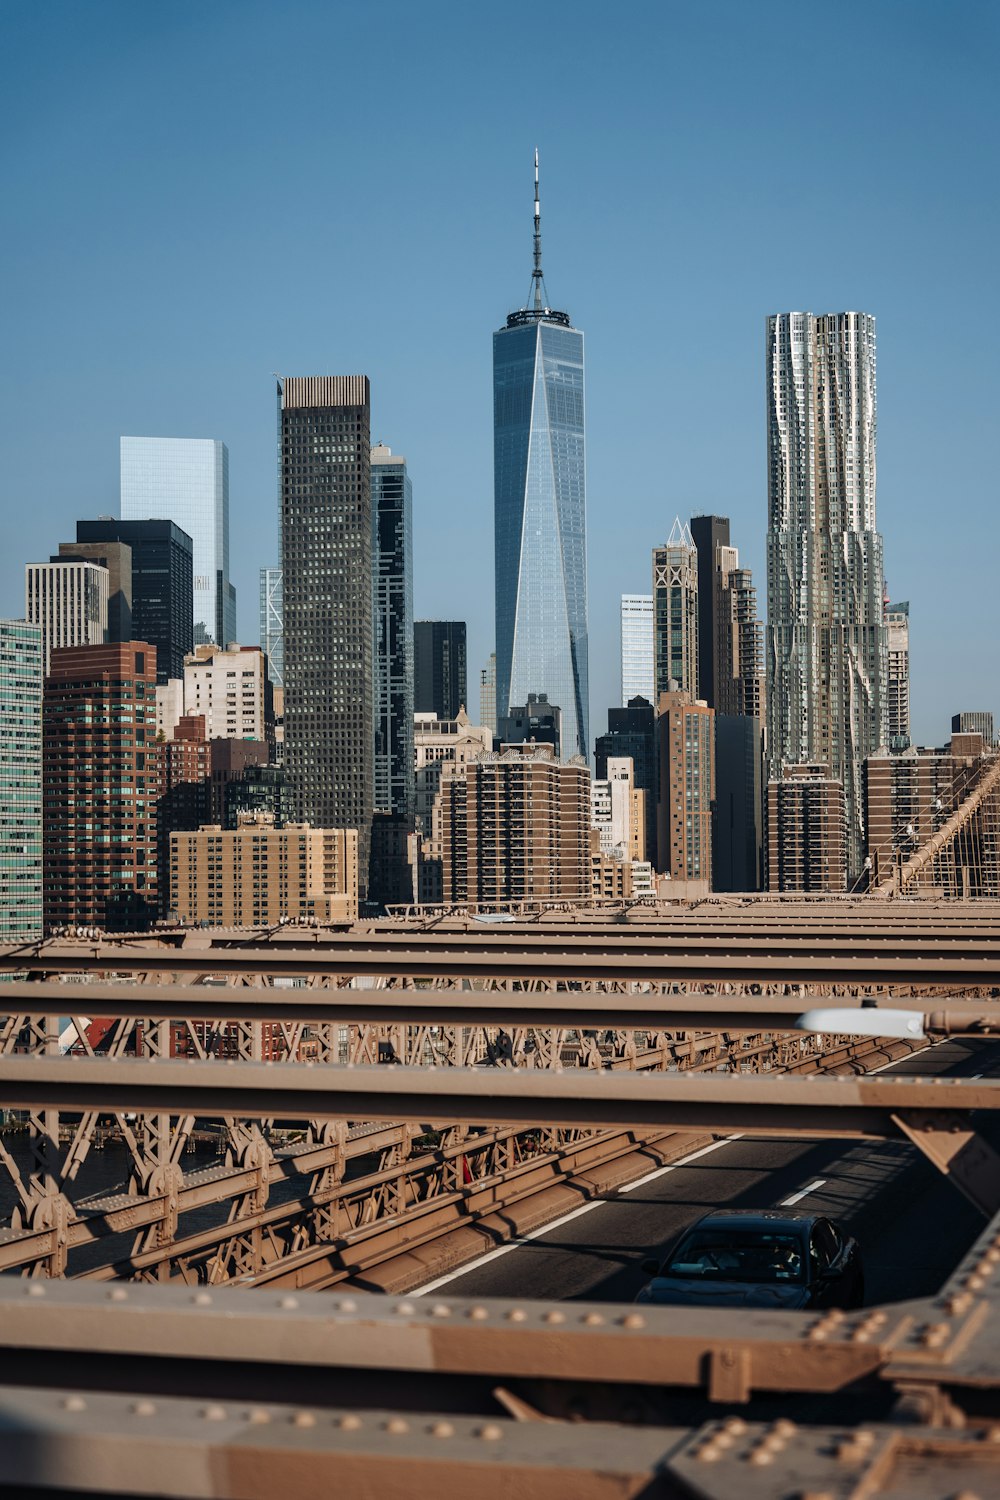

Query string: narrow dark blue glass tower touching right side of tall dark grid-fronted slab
[372,443,413,830]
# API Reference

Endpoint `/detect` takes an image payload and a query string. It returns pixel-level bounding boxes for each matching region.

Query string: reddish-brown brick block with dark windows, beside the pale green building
[42,641,162,930]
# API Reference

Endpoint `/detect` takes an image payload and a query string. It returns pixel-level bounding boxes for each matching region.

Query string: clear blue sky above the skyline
[0,0,1000,743]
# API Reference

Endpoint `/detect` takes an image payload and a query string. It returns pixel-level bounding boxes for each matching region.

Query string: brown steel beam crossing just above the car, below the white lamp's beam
[0,1056,1000,1139]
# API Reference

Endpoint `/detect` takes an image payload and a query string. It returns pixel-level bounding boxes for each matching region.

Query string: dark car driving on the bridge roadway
[636,1209,865,1308]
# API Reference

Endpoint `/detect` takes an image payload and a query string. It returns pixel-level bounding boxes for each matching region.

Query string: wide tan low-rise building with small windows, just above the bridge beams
[169,813,358,927]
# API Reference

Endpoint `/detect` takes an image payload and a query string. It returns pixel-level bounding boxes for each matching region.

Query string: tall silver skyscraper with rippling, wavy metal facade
[766,312,888,882]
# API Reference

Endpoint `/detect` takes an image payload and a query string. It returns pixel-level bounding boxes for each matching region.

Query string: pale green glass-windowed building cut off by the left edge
[0,620,45,942]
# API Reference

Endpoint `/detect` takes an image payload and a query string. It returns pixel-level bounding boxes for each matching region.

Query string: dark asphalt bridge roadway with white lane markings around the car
[415,1041,1000,1305]
